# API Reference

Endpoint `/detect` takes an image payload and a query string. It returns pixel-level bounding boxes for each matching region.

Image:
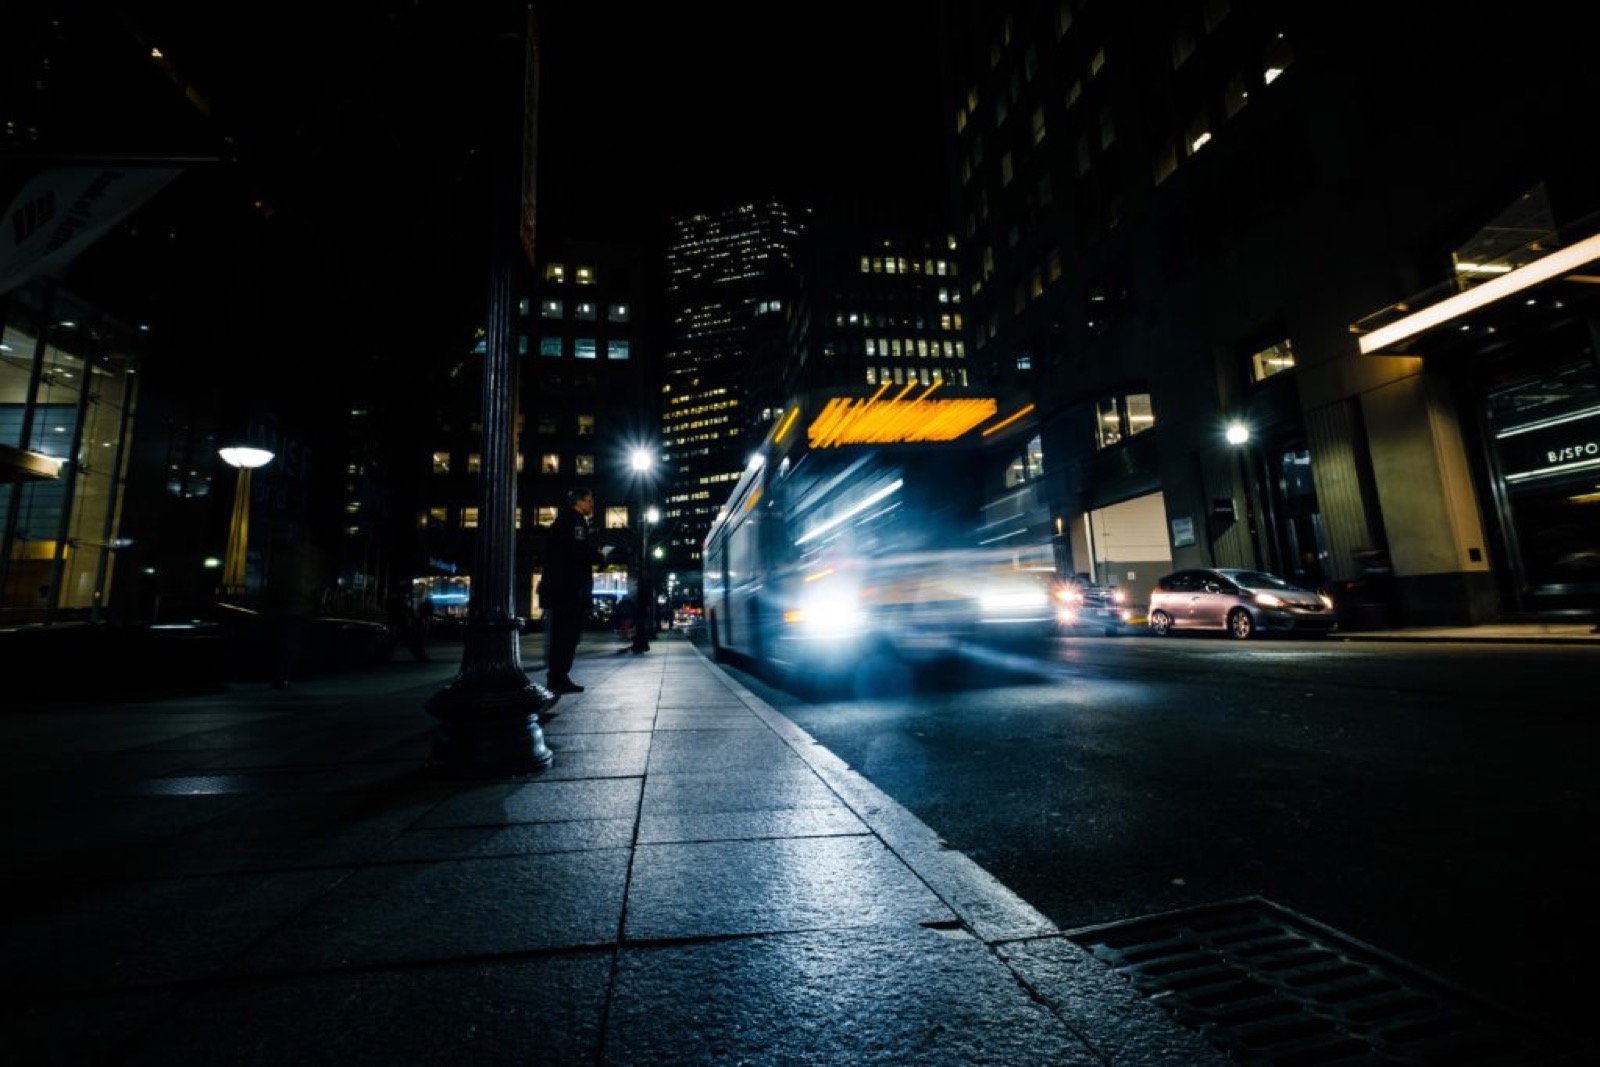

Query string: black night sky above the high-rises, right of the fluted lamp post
[539,0,946,238]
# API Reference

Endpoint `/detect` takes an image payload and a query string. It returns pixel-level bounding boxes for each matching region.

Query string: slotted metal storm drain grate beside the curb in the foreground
[1067,897,1579,1067]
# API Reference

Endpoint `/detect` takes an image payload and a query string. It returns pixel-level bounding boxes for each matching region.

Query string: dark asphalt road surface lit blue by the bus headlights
[713,635,1600,1033]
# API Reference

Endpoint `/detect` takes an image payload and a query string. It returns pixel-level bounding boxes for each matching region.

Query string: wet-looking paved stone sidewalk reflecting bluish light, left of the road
[0,633,1226,1067]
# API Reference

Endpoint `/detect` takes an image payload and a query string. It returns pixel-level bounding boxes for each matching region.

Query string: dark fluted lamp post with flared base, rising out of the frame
[427,3,557,777]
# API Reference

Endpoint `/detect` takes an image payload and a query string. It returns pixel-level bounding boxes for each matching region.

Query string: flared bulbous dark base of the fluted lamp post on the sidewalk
[427,681,560,777]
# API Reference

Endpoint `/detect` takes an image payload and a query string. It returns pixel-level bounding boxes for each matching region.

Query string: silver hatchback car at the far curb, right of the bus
[1149,566,1339,640]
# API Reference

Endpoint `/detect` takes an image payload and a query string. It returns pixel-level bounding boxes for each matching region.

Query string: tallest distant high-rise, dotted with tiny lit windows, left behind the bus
[661,200,810,571]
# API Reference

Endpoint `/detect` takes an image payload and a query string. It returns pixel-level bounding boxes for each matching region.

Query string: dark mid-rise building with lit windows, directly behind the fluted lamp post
[414,242,659,619]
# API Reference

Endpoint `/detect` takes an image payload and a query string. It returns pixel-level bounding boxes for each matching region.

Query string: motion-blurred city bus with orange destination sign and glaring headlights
[702,386,1056,694]
